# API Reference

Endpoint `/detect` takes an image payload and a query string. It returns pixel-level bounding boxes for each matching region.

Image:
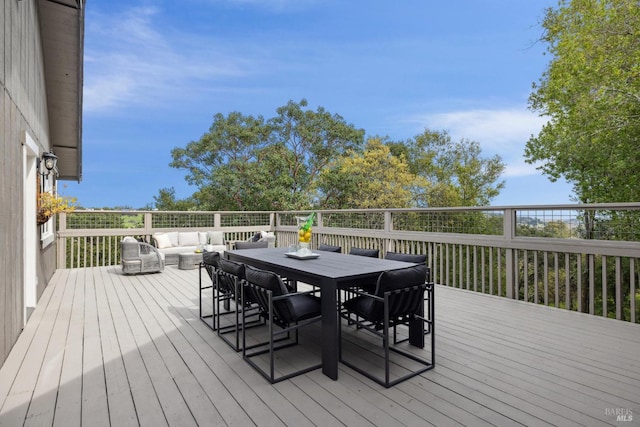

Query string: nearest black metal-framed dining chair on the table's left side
[242,265,322,384]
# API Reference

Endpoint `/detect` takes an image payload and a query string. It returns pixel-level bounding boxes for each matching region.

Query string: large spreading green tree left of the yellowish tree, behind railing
[171,99,364,210]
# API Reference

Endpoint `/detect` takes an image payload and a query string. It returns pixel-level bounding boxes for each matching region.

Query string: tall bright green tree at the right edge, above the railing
[525,0,640,203]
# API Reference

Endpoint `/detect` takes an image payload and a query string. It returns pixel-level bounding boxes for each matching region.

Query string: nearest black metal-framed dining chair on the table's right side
[339,265,435,388]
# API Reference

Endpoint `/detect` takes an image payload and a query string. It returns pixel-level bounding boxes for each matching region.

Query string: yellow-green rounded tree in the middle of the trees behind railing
[318,138,426,209]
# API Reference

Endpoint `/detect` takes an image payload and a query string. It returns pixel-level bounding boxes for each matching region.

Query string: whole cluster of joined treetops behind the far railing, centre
[168,99,504,210]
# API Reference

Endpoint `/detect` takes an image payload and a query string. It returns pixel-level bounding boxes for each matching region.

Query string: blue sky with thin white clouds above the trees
[59,0,571,208]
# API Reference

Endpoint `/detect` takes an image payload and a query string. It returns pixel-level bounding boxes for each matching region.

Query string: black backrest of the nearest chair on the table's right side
[375,264,427,318]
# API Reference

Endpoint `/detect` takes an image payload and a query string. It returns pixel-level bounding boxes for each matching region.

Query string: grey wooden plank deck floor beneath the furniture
[0,266,640,427]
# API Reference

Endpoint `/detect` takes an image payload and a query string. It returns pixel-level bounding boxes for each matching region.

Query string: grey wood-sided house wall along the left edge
[0,0,56,365]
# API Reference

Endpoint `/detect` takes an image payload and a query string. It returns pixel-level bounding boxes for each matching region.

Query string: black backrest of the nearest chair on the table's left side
[245,265,293,324]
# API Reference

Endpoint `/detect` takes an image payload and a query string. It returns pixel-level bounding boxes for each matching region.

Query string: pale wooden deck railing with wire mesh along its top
[58,203,640,322]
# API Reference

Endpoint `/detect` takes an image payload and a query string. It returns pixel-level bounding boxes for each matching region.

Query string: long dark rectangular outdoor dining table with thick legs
[225,248,424,380]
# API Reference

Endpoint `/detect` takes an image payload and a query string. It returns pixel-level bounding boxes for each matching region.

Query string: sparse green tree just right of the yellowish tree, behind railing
[388,129,505,207]
